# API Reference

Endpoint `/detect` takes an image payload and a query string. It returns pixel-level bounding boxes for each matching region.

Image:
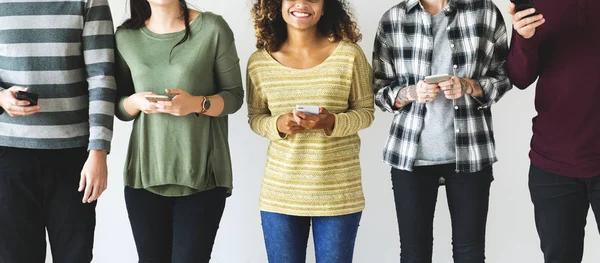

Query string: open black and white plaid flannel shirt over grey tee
[373,0,512,173]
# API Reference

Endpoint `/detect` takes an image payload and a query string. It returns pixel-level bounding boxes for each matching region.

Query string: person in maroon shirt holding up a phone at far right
[507,0,600,263]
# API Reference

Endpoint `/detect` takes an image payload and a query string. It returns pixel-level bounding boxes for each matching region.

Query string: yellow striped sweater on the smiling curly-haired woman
[247,42,374,216]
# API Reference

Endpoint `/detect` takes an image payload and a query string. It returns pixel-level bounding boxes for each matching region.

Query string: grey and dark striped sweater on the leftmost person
[0,0,116,151]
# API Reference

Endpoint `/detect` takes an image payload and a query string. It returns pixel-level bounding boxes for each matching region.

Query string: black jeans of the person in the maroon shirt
[529,164,600,263]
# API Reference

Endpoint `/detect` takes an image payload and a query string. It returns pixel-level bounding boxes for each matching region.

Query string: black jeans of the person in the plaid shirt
[392,164,494,263]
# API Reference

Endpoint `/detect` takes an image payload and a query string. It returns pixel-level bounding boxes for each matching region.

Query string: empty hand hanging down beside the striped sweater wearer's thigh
[78,150,108,203]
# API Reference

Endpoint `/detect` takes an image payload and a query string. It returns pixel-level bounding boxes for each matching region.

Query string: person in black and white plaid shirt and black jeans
[373,0,511,262]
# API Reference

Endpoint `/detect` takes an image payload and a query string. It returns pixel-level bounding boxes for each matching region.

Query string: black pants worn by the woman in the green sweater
[125,187,227,263]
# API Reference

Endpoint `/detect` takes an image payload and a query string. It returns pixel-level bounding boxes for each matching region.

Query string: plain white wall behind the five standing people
[48,0,600,263]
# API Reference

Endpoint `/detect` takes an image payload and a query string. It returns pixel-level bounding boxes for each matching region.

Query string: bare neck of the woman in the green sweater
[146,2,185,34]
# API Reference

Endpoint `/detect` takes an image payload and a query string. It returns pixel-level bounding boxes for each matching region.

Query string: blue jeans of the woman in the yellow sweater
[261,211,362,263]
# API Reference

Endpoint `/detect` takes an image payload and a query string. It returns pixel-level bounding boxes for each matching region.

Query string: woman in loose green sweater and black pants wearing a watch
[116,0,244,263]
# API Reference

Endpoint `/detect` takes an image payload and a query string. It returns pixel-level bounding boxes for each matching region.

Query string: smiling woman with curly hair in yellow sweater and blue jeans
[247,0,374,263]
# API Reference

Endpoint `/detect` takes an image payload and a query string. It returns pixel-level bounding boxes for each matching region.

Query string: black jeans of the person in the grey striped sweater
[0,147,96,263]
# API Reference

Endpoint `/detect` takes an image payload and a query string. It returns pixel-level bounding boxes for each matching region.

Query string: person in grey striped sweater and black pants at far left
[0,0,116,263]
